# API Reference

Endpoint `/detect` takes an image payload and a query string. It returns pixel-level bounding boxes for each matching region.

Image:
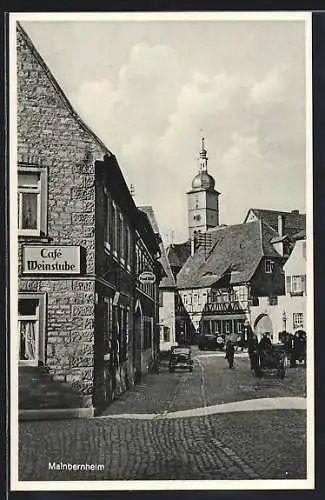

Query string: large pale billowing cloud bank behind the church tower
[68,43,304,241]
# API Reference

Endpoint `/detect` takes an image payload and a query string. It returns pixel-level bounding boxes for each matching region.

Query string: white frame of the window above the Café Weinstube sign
[17,165,47,237]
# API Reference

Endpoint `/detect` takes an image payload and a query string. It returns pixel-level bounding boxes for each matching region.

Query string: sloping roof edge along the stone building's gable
[16,21,113,156]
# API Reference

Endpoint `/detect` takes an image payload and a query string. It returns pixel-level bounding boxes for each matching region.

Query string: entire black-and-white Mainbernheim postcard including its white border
[9,12,314,491]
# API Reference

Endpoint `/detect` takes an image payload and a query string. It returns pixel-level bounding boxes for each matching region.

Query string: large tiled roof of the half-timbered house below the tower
[177,221,281,288]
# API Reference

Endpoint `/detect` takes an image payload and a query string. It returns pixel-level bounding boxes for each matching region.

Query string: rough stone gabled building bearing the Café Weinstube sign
[17,24,159,414]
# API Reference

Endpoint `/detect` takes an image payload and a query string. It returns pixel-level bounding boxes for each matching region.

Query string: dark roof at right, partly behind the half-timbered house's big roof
[245,208,306,236]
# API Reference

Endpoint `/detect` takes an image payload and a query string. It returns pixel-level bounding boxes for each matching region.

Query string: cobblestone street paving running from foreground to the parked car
[19,353,306,481]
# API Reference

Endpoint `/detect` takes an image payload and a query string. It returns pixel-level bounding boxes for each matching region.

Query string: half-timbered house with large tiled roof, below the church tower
[177,221,285,344]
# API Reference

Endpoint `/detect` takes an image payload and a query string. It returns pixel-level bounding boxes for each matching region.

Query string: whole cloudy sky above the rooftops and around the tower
[21,20,306,243]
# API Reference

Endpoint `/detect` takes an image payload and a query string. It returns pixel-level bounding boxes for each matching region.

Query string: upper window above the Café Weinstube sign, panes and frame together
[17,167,47,236]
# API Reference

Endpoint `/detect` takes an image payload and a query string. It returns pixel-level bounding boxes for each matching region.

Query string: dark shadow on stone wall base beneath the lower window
[19,366,86,410]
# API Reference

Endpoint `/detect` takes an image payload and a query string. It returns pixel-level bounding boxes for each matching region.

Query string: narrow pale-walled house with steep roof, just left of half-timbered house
[139,206,176,351]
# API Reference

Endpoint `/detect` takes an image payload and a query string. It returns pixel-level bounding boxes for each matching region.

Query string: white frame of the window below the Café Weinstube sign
[17,293,46,366]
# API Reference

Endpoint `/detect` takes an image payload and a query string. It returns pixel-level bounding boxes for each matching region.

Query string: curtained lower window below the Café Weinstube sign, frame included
[18,294,45,366]
